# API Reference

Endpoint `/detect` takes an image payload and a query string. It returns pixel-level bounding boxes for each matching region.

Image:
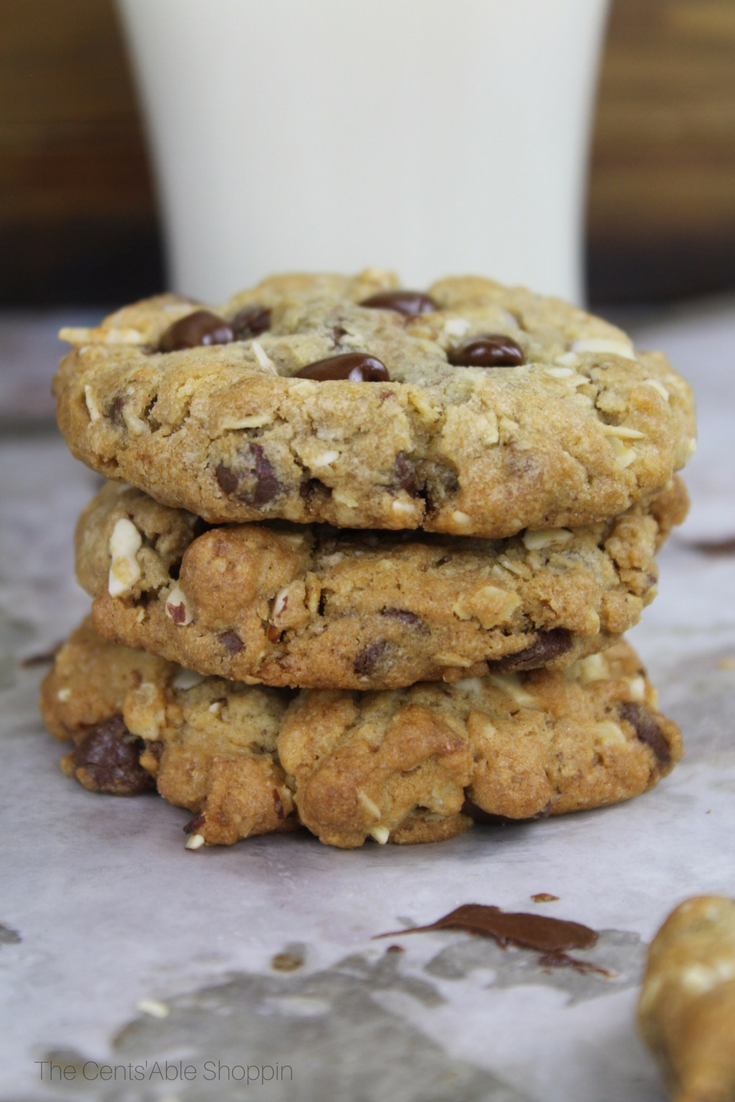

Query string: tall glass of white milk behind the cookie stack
[119,0,606,301]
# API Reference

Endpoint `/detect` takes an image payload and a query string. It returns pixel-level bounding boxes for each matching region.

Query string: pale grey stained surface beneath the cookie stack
[0,301,735,1102]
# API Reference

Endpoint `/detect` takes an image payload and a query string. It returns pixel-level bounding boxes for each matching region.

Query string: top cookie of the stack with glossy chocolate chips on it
[54,269,694,539]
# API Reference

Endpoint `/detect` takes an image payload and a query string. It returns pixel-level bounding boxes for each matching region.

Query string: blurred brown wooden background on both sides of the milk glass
[0,0,735,304]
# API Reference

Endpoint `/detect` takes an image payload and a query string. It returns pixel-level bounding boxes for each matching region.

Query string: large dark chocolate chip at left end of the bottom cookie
[72,715,154,796]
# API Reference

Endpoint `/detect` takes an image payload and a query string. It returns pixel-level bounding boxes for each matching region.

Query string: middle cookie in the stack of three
[76,478,688,689]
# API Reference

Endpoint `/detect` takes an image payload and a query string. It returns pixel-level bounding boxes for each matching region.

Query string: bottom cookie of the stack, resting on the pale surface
[41,620,682,849]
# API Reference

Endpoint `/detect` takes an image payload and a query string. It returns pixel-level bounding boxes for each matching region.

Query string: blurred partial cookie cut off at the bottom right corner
[638,896,735,1102]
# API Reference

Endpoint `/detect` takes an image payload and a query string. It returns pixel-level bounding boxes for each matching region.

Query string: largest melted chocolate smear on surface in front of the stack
[374,903,597,957]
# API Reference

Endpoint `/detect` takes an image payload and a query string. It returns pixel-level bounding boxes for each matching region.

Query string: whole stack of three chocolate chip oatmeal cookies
[42,269,694,849]
